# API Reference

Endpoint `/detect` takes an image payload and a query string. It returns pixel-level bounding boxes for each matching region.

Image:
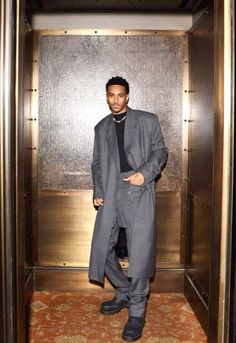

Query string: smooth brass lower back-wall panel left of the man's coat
[38,191,96,267]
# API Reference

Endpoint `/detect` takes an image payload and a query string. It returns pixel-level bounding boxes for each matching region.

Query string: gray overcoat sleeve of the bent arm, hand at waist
[137,115,168,183]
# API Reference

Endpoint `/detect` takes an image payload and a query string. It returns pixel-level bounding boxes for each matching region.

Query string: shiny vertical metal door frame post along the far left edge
[0,0,16,343]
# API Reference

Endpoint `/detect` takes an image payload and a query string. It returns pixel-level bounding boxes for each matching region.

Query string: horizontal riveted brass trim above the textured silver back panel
[34,28,185,36]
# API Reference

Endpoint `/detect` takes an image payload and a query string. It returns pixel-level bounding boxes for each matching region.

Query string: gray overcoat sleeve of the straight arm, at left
[91,130,103,199]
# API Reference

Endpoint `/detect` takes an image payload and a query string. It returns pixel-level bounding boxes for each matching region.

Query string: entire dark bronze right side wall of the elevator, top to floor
[185,10,214,336]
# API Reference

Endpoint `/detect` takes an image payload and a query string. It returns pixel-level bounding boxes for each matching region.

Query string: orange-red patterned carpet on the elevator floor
[29,290,207,343]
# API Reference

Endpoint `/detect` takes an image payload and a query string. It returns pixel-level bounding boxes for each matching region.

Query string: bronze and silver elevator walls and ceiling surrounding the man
[0,0,234,342]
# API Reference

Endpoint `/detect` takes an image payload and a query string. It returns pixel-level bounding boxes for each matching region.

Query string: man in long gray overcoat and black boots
[89,76,167,341]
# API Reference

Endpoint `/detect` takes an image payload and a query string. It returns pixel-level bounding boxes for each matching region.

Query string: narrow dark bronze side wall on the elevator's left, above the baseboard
[22,26,35,279]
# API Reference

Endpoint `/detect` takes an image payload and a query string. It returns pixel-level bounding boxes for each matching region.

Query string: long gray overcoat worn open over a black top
[89,107,167,283]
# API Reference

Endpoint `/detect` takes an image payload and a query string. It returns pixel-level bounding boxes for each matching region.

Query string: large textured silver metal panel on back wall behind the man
[39,34,184,191]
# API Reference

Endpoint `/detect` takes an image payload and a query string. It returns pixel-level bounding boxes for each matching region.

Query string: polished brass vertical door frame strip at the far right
[218,0,234,342]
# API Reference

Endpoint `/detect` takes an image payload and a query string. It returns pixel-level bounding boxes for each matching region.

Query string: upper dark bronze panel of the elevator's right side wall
[189,14,214,205]
